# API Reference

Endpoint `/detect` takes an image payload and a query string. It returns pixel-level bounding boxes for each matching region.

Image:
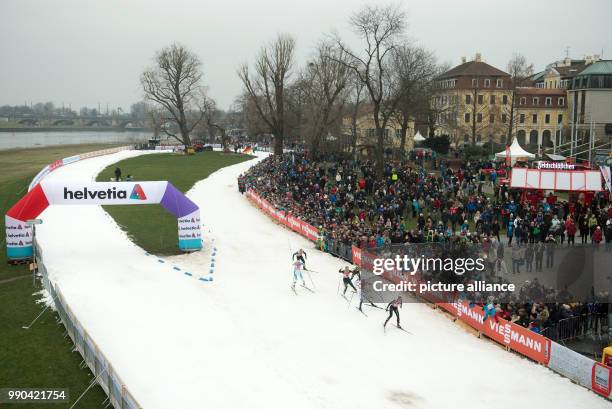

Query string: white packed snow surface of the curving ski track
[37,151,610,409]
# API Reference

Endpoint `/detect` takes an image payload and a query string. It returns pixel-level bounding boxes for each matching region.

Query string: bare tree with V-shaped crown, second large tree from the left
[238,35,295,155]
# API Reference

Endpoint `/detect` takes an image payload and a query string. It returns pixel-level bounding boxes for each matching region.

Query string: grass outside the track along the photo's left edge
[0,144,125,408]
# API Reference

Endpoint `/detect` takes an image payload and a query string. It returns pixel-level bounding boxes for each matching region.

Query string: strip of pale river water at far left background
[0,131,152,150]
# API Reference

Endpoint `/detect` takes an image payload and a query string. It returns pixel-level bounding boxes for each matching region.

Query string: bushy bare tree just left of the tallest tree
[301,42,351,158]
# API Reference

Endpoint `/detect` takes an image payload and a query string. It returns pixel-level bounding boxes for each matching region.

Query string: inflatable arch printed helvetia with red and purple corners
[5,180,202,260]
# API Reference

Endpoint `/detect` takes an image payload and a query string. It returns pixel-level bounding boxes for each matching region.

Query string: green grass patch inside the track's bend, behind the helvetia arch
[98,152,251,255]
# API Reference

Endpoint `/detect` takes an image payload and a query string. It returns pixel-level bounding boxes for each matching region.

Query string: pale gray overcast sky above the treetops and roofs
[0,0,612,109]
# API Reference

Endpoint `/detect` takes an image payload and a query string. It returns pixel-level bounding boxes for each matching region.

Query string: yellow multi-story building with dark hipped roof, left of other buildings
[432,54,512,145]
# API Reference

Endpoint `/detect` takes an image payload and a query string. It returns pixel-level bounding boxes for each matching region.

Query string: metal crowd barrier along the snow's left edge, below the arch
[34,242,141,409]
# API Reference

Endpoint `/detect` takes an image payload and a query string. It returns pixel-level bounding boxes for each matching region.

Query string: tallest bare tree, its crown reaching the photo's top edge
[336,5,406,173]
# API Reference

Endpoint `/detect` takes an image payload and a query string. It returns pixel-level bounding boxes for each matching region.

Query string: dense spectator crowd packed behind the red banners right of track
[238,152,612,332]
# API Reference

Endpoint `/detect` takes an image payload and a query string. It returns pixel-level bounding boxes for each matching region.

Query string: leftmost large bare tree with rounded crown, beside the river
[140,44,204,146]
